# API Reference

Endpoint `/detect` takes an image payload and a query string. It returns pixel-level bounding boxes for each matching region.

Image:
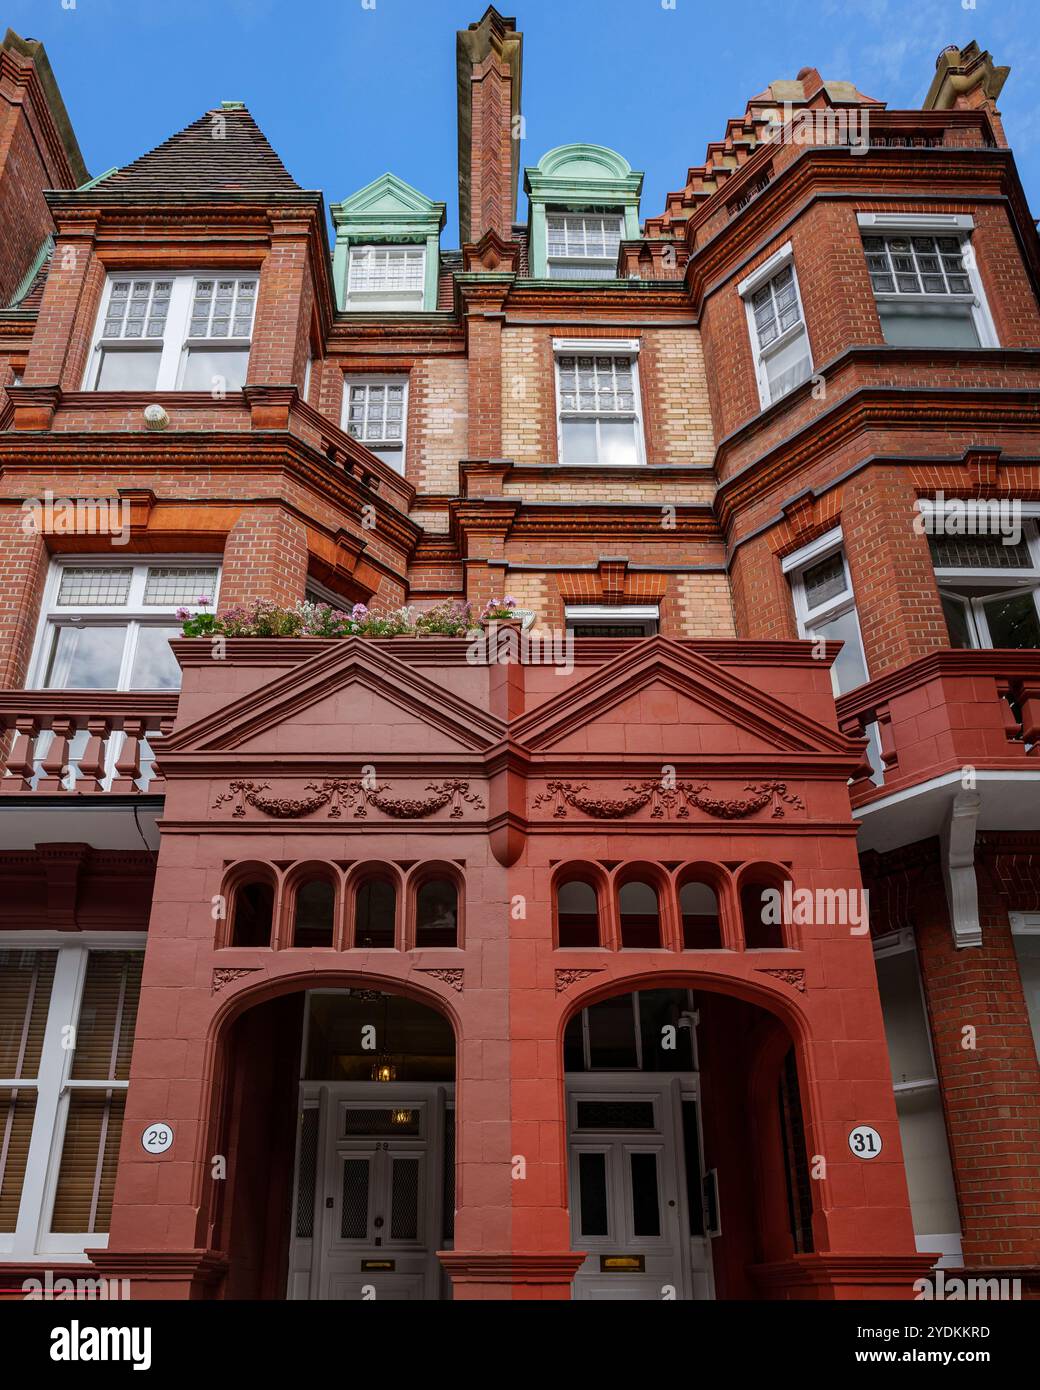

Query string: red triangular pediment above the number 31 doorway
[510,637,850,758]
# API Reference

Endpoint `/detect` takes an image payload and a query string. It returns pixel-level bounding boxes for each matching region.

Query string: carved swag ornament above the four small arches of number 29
[213,777,484,820]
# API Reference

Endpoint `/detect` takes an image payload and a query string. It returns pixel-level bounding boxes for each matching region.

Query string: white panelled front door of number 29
[289,1083,453,1300]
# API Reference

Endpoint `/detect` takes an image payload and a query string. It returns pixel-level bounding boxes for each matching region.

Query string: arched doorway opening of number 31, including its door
[563,987,813,1300]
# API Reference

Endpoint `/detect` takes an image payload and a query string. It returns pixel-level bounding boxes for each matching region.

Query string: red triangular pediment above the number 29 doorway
[163,638,505,765]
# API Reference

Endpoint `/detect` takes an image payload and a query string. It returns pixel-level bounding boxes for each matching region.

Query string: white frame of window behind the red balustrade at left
[29,552,221,692]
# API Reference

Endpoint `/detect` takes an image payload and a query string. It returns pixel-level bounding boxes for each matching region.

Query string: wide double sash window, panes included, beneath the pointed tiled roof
[83,272,259,398]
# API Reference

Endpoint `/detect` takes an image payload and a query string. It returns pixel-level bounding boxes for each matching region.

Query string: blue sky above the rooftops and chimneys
[4,0,1040,246]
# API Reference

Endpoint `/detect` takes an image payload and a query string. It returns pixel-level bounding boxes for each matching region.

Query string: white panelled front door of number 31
[567,1072,713,1300]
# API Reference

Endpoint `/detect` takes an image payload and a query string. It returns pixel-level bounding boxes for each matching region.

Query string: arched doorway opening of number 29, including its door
[218,988,455,1301]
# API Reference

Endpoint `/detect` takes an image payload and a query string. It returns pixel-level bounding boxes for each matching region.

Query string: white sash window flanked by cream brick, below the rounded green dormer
[553,339,645,467]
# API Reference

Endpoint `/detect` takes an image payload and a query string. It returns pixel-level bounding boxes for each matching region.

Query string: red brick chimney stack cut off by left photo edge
[0,29,88,304]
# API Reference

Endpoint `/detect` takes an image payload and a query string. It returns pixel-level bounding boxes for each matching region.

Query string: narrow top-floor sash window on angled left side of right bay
[737,242,812,410]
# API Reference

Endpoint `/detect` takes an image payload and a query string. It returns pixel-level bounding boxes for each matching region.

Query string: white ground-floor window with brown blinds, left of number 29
[0,933,145,1261]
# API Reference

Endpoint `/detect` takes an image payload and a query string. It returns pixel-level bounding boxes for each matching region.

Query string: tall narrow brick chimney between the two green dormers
[456,6,524,243]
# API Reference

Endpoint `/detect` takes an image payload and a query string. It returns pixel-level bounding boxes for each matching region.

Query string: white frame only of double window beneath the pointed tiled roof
[82,270,260,393]
